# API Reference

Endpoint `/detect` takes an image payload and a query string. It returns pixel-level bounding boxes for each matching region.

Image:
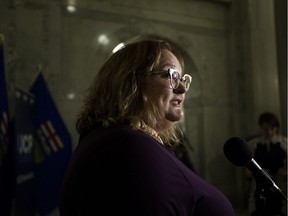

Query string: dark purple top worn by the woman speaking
[59,126,236,216]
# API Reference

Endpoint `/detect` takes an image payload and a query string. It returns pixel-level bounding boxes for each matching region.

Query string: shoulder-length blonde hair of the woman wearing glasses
[76,38,184,145]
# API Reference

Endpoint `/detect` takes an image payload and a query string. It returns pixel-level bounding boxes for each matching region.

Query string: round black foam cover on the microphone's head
[223,137,253,166]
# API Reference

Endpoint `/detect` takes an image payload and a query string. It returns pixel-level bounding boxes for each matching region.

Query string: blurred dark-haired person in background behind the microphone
[246,112,287,216]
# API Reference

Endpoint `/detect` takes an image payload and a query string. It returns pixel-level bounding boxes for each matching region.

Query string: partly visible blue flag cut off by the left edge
[0,35,12,216]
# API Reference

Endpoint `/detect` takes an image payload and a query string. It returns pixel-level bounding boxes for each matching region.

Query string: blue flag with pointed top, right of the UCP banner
[30,73,72,216]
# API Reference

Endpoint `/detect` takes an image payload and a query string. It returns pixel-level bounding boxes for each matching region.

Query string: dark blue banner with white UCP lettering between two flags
[13,88,35,216]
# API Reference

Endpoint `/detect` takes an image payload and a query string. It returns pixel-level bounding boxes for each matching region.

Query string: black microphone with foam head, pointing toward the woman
[223,137,287,200]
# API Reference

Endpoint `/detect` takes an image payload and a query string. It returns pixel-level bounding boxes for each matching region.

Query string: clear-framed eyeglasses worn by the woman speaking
[149,68,192,90]
